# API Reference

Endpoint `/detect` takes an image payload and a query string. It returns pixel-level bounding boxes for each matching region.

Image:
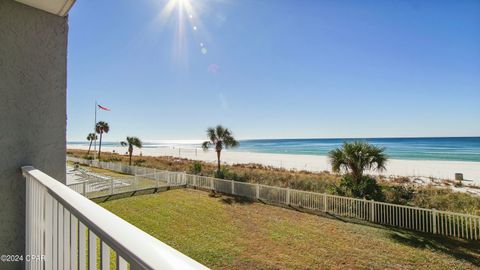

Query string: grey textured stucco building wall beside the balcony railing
[0,0,68,269]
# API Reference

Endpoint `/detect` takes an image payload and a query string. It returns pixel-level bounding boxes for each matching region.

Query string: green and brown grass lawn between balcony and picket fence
[100,189,480,269]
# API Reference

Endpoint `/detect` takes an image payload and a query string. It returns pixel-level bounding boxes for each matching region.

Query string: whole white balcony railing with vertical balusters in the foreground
[22,166,207,270]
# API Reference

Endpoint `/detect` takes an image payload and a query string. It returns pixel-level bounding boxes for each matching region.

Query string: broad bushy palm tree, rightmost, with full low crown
[329,141,388,183]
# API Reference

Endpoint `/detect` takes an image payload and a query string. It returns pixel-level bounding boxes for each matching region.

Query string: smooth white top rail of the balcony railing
[22,166,208,269]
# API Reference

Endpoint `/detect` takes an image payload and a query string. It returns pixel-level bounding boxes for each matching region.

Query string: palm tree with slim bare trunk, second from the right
[202,125,239,172]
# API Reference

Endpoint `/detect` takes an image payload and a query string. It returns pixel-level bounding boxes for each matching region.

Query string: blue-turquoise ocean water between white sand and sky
[68,137,480,162]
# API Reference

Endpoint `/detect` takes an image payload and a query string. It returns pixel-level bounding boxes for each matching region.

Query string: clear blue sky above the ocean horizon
[67,0,480,141]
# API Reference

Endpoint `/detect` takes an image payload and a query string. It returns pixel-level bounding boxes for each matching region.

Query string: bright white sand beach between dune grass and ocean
[67,145,480,185]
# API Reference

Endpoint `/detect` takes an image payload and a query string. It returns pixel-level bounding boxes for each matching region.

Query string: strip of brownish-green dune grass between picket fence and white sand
[67,150,480,215]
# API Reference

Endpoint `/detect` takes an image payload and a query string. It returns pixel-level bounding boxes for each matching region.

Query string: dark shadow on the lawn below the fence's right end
[388,228,480,267]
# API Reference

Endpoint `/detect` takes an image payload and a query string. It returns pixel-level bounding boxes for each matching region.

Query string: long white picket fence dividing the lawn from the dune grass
[67,157,480,240]
